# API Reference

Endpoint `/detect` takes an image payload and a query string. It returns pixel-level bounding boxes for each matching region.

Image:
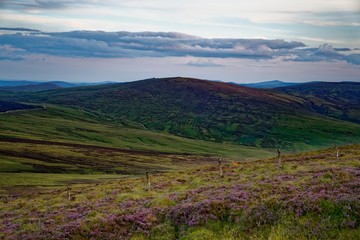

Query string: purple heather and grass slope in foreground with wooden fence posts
[0,145,360,239]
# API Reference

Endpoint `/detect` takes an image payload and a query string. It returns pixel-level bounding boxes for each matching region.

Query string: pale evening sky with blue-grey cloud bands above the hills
[0,0,360,83]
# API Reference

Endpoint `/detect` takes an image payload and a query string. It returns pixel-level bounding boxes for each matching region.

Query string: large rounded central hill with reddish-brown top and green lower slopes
[12,77,360,149]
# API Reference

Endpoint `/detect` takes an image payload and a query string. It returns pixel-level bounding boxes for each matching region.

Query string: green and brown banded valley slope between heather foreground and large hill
[0,105,276,187]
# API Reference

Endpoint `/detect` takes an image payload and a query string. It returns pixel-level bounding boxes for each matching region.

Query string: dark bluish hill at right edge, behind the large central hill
[274,82,360,123]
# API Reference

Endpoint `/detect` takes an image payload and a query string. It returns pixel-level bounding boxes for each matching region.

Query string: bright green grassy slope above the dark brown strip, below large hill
[0,105,272,160]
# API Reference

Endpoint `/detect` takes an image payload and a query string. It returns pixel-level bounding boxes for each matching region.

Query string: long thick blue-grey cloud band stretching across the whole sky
[0,29,359,66]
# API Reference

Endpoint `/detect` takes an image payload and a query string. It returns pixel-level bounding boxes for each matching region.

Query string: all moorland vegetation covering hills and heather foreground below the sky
[0,78,360,240]
